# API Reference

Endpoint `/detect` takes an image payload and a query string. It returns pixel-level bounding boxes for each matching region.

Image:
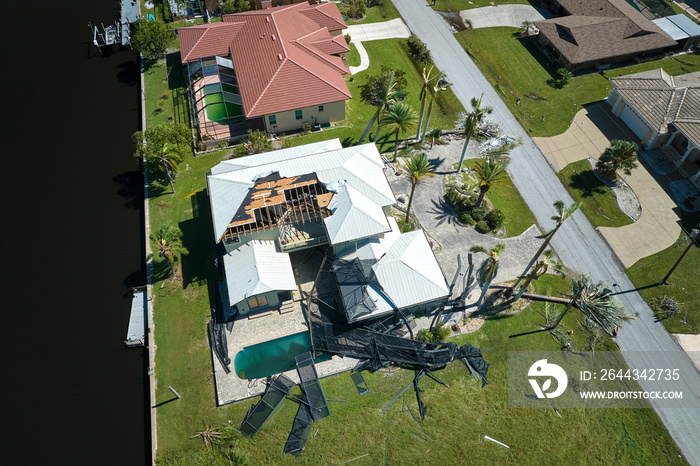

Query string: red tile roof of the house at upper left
[179,3,351,118]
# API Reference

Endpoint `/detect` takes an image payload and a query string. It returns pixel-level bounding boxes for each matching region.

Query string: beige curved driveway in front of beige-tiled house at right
[532,102,681,267]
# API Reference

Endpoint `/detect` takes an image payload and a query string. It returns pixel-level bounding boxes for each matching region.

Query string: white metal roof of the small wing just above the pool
[223,240,297,305]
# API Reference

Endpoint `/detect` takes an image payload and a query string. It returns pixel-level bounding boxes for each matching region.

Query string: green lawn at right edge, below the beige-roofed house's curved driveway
[627,212,700,334]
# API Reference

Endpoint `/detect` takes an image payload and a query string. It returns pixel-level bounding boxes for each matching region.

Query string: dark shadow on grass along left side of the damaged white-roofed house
[178,190,216,288]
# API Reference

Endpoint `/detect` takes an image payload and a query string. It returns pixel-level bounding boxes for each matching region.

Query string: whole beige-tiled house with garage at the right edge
[607,69,700,188]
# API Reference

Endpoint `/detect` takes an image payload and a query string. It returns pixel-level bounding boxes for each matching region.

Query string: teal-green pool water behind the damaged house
[233,332,331,380]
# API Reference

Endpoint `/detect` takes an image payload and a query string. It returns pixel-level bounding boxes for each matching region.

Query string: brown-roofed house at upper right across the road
[535,0,678,72]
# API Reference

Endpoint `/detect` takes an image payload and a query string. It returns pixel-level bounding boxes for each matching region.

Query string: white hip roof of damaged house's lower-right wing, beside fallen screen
[343,217,449,319]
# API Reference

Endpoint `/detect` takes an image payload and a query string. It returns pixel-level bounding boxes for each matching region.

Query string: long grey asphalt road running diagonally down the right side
[394,0,700,465]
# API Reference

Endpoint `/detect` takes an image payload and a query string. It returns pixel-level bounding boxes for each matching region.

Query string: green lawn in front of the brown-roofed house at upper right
[455,27,700,136]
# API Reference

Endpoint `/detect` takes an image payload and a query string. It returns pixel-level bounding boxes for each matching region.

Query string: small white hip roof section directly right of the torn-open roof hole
[323,184,391,245]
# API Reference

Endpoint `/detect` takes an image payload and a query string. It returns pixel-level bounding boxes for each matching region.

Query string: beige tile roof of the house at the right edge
[610,69,700,146]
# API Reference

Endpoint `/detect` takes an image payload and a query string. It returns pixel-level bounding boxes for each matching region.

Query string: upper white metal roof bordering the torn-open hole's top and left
[207,143,395,241]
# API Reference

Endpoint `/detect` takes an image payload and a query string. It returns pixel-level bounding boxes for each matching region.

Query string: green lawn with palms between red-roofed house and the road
[289,39,464,152]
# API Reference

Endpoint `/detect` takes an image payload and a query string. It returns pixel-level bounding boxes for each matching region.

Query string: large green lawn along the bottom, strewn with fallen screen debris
[159,266,683,465]
